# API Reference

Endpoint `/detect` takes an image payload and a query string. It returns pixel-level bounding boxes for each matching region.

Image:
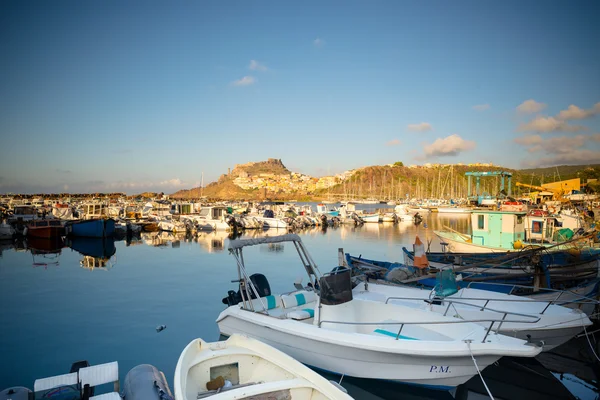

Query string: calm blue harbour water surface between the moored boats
[0,215,598,399]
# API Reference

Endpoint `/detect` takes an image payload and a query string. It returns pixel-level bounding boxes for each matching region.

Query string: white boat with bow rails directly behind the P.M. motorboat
[353,271,592,351]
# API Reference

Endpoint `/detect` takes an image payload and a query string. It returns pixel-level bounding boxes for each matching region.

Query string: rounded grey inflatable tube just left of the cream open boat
[122,364,173,400]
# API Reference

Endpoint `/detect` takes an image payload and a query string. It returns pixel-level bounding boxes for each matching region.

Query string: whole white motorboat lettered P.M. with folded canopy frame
[217,234,542,390]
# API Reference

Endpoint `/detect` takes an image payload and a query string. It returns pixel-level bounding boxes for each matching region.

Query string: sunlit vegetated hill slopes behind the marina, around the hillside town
[171,159,600,200]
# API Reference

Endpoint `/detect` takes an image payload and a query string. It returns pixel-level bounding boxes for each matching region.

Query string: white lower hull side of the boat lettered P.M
[218,314,500,390]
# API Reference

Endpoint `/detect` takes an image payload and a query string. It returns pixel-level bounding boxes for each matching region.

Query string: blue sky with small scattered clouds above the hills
[0,0,600,193]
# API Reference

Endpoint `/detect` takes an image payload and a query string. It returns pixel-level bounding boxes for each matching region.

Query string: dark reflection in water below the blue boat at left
[67,237,117,271]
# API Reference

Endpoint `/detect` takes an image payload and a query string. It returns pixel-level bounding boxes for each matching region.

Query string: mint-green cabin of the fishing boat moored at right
[471,210,526,250]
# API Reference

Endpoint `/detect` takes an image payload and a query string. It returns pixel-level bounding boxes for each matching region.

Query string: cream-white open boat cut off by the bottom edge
[174,334,352,400]
